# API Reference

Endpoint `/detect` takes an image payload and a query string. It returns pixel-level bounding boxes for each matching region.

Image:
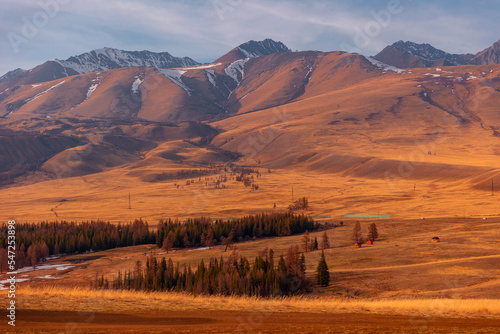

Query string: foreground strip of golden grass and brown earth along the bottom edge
[0,287,500,333]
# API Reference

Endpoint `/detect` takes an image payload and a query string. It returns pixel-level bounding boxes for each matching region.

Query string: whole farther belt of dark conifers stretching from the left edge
[0,213,317,272]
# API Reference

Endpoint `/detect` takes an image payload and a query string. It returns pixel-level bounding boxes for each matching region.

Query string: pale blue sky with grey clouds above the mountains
[0,0,500,75]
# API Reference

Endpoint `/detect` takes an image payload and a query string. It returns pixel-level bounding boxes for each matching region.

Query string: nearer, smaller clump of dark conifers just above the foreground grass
[95,246,311,297]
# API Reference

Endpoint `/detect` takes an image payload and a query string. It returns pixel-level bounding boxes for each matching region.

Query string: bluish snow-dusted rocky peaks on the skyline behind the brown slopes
[0,39,500,89]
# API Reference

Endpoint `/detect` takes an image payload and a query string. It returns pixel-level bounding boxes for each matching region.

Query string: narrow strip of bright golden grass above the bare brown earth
[4,286,500,318]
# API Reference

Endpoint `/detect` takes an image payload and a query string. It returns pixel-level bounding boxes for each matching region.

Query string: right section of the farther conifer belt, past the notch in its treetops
[156,213,317,252]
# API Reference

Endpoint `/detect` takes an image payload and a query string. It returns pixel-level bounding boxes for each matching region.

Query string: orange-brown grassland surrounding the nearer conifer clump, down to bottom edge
[0,219,500,333]
